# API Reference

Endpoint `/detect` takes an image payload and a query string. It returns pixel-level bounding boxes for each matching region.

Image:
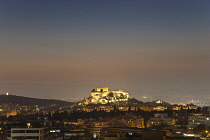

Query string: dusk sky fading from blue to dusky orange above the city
[0,0,210,99]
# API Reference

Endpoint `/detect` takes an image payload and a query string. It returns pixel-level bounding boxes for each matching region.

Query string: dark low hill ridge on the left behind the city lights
[0,95,71,106]
